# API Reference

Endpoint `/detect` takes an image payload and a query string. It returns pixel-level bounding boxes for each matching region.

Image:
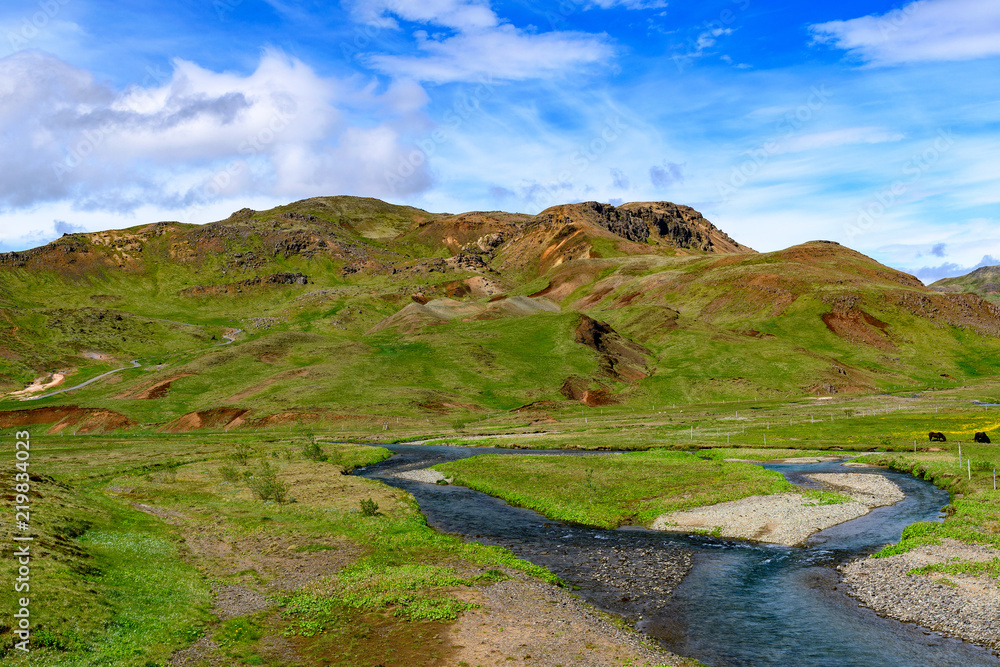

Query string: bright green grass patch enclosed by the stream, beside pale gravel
[435,450,795,528]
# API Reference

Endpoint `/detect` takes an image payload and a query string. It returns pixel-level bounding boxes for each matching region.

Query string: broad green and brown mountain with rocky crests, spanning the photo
[0,197,1000,430]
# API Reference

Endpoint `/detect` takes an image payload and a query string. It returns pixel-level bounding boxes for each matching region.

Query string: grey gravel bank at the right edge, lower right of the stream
[839,540,1000,648]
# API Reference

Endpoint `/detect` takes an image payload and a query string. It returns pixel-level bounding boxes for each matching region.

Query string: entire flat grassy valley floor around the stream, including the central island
[0,383,1000,666]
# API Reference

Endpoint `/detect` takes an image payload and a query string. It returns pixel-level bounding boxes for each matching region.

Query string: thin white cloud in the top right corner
[810,0,1000,65]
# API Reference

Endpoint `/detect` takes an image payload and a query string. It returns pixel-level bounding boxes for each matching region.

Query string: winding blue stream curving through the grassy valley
[358,445,1000,667]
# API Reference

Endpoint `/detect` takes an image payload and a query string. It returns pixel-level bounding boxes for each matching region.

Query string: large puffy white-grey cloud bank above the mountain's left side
[0,51,430,217]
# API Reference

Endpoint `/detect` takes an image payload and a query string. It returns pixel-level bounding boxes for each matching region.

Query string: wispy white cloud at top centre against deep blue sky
[351,0,614,83]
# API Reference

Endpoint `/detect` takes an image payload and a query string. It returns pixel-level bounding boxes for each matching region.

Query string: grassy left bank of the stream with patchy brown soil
[0,436,555,667]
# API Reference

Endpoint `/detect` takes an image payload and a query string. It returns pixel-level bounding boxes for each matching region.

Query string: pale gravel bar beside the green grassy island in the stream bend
[650,473,904,546]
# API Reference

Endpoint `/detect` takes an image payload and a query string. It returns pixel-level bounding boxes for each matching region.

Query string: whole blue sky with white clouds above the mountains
[0,0,1000,282]
